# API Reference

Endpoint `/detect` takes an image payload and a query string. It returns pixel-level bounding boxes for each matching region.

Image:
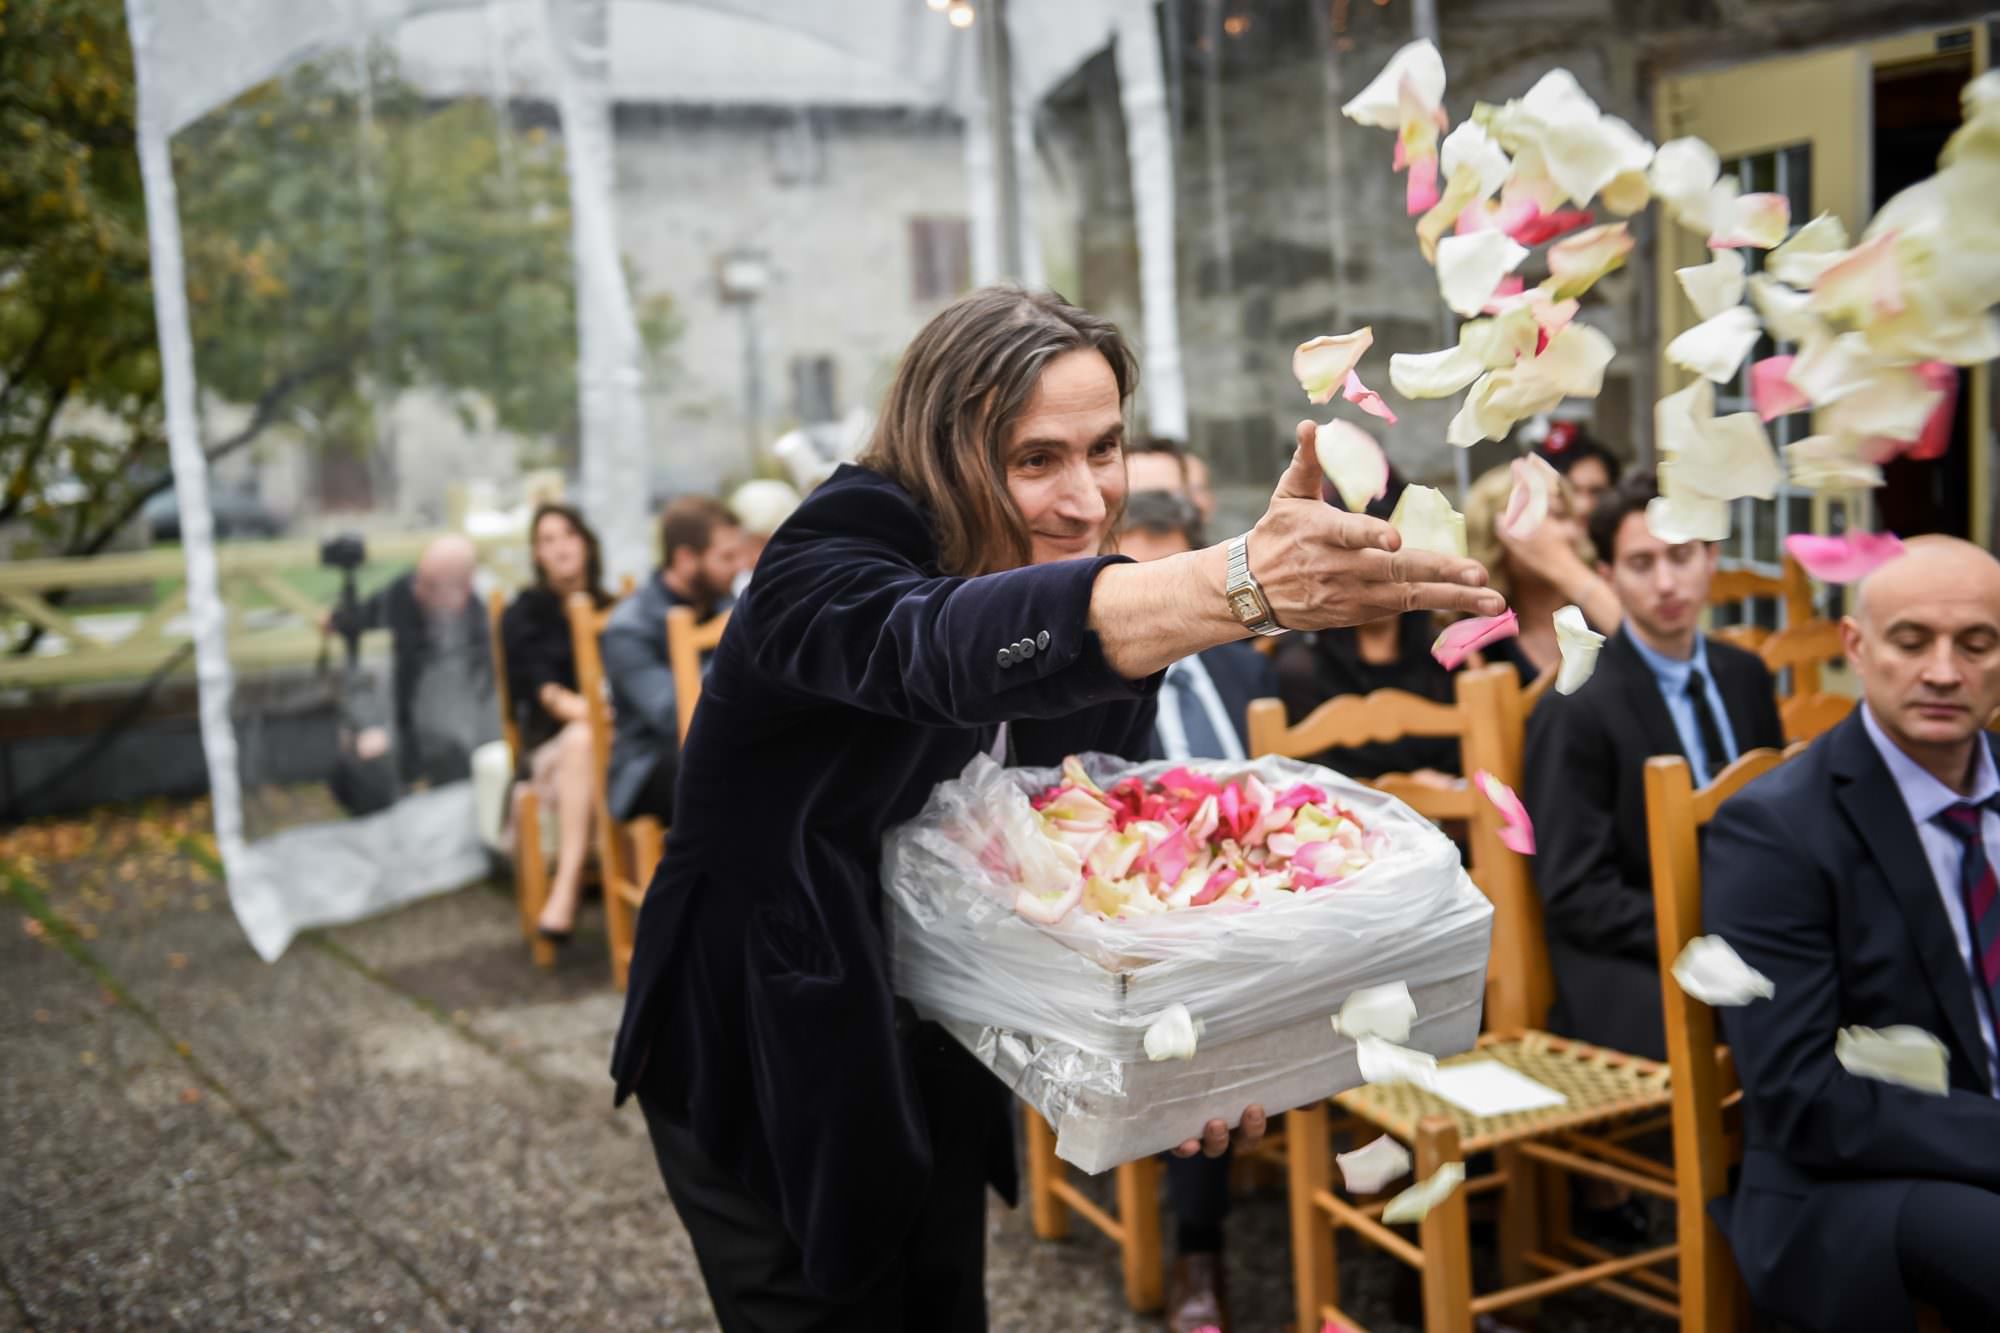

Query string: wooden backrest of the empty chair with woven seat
[1248,664,1554,1031]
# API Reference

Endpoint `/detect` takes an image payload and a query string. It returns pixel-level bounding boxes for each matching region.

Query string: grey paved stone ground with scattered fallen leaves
[0,809,1670,1333]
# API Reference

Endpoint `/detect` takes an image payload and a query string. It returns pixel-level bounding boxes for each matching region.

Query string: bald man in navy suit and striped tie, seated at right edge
[1702,538,2000,1333]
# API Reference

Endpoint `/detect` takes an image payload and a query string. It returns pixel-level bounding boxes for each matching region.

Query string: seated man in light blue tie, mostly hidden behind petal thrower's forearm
[1118,490,1278,1333]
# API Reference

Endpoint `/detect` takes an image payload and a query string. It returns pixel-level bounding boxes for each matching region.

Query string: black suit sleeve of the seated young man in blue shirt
[1522,695,1658,963]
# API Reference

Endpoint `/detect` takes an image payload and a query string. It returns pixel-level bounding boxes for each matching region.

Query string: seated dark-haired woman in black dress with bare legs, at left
[500,504,608,945]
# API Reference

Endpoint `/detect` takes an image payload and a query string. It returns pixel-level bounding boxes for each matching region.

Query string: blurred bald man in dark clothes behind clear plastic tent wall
[324,532,500,787]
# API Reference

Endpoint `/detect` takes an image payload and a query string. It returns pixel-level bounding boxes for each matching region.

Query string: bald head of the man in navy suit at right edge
[1840,536,2000,753]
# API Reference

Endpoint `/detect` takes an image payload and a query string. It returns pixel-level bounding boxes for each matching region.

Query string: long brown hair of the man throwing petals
[860,286,1138,574]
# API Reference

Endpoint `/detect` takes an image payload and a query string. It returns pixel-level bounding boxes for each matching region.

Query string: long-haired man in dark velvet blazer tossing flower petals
[612,288,1498,1333]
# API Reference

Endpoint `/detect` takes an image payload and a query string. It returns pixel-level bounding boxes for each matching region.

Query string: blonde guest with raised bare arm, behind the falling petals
[1464,466,1620,685]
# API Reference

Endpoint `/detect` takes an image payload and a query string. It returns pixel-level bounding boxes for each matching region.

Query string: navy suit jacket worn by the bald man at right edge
[1702,709,2000,1333]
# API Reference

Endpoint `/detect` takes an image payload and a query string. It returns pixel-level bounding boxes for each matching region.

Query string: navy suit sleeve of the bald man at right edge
[1702,795,2000,1189]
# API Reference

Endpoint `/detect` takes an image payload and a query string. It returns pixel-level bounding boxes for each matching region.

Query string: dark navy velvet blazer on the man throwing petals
[612,466,1160,1295]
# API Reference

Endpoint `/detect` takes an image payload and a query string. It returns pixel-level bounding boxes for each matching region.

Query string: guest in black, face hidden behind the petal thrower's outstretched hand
[1276,468,1458,787]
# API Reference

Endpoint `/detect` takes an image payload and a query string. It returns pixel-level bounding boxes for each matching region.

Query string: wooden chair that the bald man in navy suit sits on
[1646,743,1804,1333]
